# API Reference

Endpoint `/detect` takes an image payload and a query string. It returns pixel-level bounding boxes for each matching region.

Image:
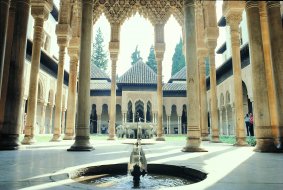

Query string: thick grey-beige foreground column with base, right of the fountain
[182,0,205,152]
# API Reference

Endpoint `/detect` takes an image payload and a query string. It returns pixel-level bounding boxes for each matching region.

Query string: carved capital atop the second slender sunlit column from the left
[55,24,72,47]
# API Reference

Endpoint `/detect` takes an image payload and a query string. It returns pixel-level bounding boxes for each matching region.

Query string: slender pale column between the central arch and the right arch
[154,24,165,141]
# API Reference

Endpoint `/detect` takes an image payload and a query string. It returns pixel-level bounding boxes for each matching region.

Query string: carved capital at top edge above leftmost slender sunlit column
[31,0,53,20]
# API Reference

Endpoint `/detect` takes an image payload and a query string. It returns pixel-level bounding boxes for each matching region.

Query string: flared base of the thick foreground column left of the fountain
[67,136,94,151]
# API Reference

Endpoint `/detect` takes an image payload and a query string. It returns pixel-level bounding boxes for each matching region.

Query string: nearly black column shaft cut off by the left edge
[0,0,16,130]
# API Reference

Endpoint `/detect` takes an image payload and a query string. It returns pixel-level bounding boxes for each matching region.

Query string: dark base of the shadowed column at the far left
[0,134,21,150]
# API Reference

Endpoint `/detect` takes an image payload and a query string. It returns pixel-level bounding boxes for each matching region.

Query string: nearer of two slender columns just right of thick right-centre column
[204,1,220,143]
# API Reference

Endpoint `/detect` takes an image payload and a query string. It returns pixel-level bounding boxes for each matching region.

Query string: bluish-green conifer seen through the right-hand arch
[171,38,185,76]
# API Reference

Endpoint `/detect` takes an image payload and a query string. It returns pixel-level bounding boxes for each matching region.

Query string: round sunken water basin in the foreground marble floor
[69,163,207,189]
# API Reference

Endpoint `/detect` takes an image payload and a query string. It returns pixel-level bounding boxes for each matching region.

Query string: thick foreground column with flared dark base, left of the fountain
[68,0,94,151]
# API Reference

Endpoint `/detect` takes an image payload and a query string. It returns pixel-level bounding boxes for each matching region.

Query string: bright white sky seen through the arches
[54,0,225,82]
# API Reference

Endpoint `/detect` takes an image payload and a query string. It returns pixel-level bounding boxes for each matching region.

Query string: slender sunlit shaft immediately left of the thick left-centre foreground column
[64,55,78,140]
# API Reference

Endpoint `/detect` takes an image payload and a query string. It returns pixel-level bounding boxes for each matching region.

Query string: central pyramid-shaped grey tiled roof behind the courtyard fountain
[117,60,157,84]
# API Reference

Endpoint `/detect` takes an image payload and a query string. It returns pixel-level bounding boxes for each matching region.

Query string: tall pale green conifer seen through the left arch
[91,28,108,71]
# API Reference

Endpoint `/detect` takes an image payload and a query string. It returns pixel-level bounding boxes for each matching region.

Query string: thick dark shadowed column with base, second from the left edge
[0,0,30,150]
